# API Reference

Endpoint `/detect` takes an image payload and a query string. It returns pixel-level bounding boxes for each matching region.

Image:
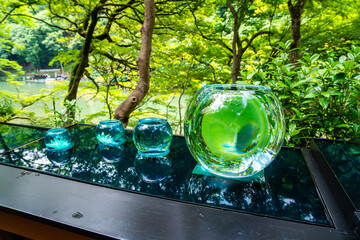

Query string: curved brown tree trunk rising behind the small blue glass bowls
[114,0,155,127]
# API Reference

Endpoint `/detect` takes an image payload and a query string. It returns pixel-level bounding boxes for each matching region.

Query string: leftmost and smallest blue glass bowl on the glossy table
[44,128,73,151]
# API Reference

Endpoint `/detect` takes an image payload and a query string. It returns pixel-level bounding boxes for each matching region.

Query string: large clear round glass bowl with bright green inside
[184,84,285,178]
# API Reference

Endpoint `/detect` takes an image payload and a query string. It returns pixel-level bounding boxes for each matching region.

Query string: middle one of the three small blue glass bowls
[96,120,125,146]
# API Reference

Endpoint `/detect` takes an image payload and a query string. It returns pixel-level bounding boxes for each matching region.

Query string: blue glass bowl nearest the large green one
[133,118,173,157]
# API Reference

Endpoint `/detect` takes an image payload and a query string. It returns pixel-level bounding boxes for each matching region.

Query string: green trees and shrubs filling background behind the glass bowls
[0,0,360,147]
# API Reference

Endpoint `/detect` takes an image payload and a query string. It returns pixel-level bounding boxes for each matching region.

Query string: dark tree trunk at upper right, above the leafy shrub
[288,0,306,64]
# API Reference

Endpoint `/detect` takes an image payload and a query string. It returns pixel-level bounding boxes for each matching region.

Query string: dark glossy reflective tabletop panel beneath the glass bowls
[0,125,330,226]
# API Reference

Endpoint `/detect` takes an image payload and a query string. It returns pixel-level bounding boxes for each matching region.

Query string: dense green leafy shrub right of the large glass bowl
[247,43,360,147]
